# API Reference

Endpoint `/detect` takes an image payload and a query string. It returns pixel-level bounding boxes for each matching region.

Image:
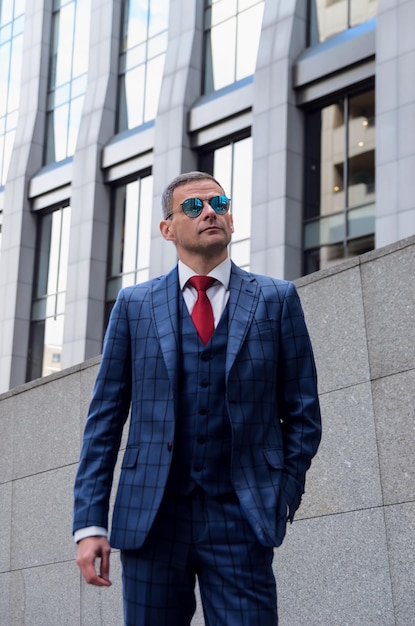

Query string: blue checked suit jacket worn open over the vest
[73,264,321,549]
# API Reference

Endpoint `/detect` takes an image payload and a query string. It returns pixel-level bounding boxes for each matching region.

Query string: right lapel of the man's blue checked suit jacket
[226,263,259,373]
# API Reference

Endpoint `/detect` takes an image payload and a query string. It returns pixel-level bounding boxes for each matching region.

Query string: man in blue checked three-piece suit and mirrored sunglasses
[73,172,321,626]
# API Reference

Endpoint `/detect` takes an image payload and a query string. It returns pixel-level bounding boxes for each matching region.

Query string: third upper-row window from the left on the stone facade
[117,0,169,132]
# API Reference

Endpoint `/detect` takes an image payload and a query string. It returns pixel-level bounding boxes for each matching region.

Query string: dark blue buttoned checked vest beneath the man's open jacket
[167,297,234,495]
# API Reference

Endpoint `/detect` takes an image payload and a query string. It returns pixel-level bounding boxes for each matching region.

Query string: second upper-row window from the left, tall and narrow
[45,0,90,163]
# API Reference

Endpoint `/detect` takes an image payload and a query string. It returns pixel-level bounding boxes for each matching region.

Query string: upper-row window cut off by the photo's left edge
[0,0,25,186]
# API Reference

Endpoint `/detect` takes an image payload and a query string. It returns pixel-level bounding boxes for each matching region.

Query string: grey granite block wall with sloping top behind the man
[0,237,415,626]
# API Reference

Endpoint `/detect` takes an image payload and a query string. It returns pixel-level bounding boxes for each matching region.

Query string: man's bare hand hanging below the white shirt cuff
[76,537,111,587]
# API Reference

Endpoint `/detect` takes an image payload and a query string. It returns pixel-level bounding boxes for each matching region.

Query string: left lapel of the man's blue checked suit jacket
[151,266,180,390]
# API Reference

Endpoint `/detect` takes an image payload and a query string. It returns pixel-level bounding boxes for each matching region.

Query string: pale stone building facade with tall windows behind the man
[0,0,415,391]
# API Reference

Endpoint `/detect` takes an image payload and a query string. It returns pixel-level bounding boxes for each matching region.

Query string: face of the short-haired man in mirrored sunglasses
[160,179,233,264]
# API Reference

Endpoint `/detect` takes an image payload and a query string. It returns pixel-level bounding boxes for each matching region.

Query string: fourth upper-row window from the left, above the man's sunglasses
[203,0,264,93]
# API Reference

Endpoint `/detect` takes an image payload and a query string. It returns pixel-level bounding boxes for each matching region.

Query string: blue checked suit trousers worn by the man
[121,490,278,626]
